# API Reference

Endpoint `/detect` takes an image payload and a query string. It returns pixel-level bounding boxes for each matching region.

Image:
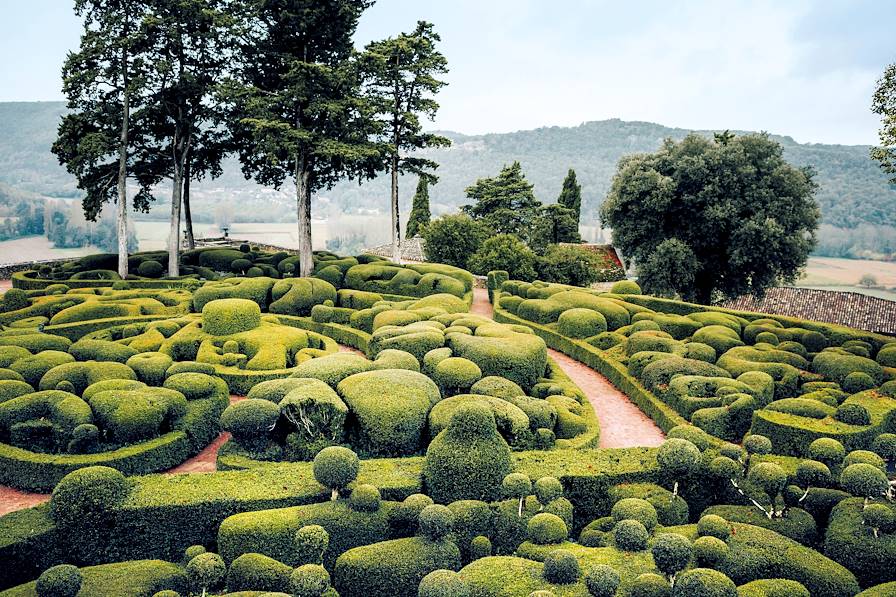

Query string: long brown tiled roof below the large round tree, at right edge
[721,287,896,335]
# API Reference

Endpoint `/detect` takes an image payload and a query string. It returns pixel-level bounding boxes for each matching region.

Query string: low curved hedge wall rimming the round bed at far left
[0,397,229,492]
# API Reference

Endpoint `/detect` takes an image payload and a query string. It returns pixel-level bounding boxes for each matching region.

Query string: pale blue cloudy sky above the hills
[0,0,896,144]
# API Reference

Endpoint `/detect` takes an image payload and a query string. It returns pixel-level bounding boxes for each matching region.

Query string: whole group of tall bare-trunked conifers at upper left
[52,0,450,276]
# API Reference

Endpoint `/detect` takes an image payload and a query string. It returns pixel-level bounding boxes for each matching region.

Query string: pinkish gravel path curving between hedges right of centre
[470,288,665,448]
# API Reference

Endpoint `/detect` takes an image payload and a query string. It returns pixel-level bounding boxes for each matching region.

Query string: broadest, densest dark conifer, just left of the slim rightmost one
[225,0,382,276]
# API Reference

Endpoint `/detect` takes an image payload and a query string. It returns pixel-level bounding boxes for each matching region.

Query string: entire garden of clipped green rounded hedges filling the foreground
[0,251,896,597]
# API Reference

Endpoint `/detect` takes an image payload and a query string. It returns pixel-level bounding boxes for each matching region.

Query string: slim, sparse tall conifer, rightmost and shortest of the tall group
[363,21,451,262]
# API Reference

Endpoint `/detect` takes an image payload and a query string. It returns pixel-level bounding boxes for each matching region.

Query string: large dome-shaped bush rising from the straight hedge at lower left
[50,466,130,528]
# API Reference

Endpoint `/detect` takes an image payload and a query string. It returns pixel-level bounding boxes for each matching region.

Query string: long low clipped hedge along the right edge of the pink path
[494,292,690,431]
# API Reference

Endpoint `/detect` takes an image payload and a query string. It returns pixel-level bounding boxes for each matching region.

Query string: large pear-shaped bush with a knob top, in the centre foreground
[423,403,511,503]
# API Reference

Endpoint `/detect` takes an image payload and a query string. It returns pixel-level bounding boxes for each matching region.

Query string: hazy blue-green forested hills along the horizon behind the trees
[0,102,896,227]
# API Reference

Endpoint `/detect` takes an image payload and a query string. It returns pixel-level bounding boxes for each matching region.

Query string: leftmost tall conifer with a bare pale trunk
[52,0,158,278]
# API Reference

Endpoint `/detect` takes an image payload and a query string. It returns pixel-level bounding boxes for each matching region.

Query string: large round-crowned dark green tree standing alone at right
[601,132,820,303]
